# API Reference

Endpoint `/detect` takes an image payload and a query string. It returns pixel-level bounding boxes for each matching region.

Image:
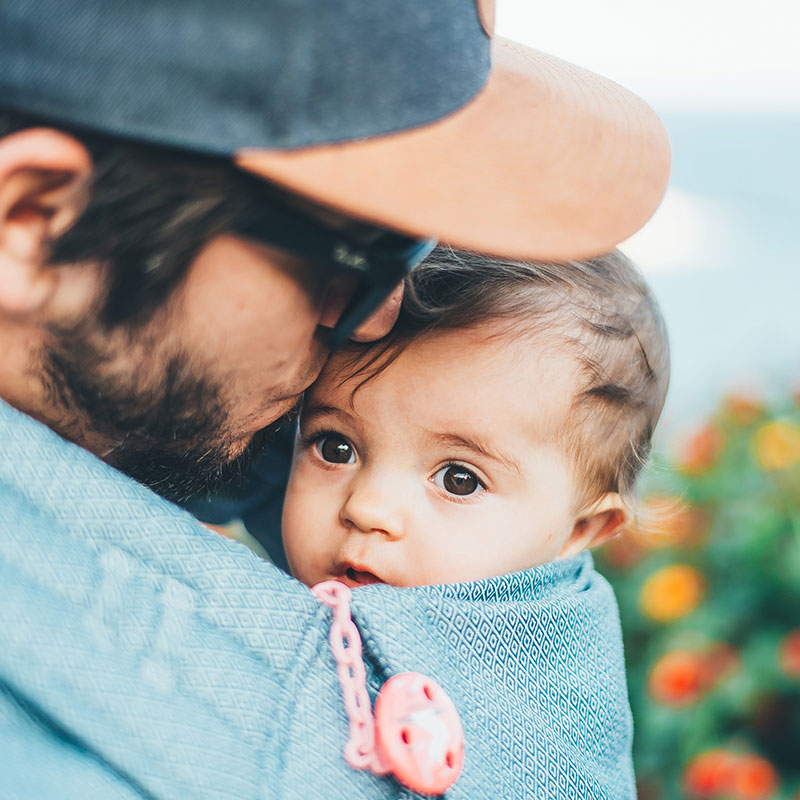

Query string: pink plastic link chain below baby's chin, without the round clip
[311,581,391,775]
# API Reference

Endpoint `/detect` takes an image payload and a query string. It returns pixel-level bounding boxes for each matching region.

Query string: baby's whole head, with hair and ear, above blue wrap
[283,248,669,587]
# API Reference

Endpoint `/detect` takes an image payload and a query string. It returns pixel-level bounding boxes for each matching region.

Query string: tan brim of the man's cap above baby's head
[235,38,669,259]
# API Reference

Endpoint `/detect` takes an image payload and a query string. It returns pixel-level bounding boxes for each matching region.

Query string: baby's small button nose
[339,475,411,539]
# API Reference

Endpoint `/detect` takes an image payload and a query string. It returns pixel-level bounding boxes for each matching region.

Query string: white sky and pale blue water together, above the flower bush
[497,0,800,430]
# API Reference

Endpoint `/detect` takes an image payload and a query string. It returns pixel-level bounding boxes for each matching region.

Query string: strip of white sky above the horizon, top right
[496,0,800,113]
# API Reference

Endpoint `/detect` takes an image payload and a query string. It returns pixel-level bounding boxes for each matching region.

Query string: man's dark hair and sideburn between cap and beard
[0,108,288,328]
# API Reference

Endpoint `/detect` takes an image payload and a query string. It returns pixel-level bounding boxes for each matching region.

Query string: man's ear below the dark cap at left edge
[0,128,92,316]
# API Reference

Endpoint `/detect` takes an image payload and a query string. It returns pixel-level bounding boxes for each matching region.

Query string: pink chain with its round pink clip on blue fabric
[311,581,464,794]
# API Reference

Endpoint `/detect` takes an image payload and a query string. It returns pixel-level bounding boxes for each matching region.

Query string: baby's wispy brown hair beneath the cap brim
[353,247,669,506]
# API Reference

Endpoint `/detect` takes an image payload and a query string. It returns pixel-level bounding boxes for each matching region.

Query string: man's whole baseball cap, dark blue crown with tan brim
[0,0,669,258]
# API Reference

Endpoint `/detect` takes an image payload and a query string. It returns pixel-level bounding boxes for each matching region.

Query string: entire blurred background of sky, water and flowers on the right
[497,0,800,800]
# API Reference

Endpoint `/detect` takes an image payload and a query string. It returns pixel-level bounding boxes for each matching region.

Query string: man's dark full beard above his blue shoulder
[42,326,290,502]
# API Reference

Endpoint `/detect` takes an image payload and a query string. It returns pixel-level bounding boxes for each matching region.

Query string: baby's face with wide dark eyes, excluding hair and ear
[283,328,577,586]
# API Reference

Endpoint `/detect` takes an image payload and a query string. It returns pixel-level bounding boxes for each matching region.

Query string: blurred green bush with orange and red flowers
[597,393,800,800]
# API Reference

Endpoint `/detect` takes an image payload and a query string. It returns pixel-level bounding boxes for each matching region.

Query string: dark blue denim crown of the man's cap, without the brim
[0,0,490,156]
